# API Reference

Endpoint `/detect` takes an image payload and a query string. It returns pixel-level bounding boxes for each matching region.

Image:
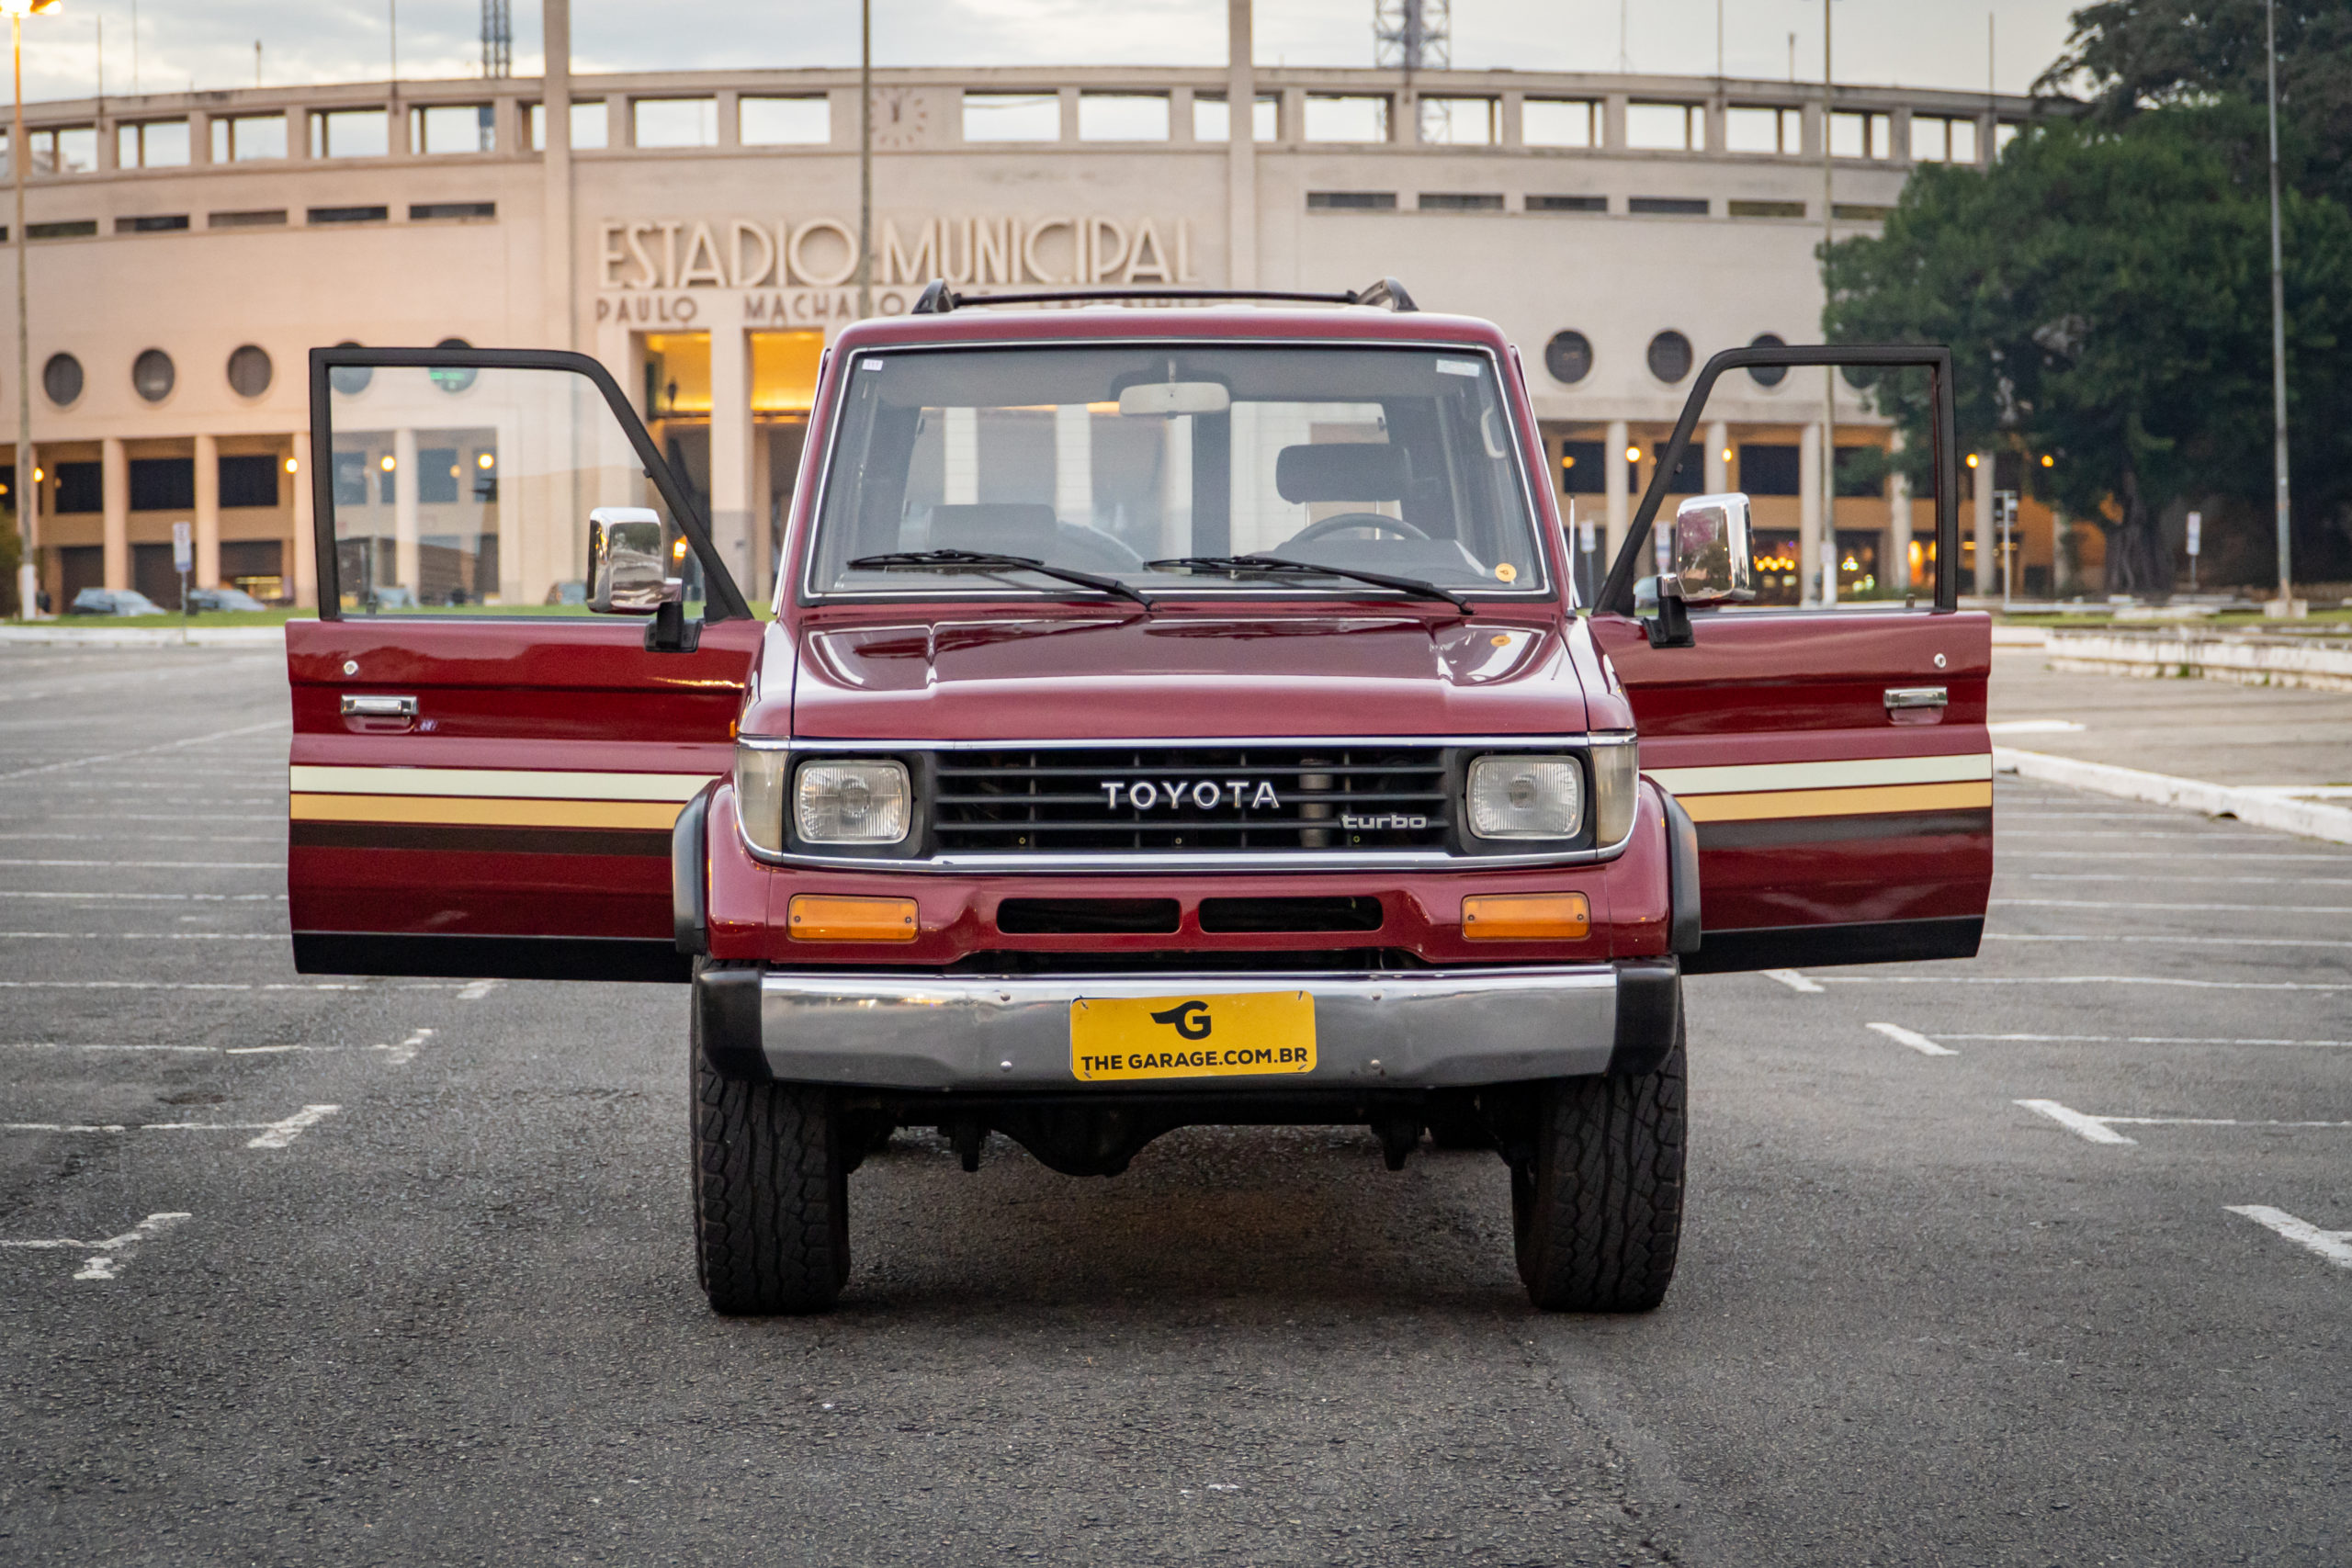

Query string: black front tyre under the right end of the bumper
[1510,1025,1684,1312]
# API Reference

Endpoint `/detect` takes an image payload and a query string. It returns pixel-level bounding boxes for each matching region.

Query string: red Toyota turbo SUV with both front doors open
[287,282,1992,1312]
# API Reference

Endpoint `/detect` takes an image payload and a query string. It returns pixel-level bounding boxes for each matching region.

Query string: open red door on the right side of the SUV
[1592,345,1992,974]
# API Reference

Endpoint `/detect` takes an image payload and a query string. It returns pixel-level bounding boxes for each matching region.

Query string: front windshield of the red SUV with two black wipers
[807,344,1545,597]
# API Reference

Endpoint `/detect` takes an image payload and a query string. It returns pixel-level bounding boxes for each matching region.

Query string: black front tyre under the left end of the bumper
[694,1006,849,1314]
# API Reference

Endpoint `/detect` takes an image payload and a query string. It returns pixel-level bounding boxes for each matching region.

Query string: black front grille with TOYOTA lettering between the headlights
[932,745,1452,856]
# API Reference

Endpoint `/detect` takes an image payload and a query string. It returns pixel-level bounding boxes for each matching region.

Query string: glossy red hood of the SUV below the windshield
[793,616,1585,740]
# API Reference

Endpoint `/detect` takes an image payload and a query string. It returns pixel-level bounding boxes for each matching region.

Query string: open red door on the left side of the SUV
[287,345,760,980]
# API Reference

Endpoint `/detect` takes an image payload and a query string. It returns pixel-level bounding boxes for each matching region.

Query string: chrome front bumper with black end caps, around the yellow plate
[696,959,1679,1093]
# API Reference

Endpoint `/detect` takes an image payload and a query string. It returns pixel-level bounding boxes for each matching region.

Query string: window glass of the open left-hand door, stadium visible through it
[322,365,703,616]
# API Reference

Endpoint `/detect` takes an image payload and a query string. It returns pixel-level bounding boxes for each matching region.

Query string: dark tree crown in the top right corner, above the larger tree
[2034,0,2352,205]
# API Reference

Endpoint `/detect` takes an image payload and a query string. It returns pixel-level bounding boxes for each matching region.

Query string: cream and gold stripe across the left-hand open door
[287,766,713,832]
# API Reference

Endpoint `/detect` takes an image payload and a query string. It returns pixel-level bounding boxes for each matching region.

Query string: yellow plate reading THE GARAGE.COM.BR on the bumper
[1070,992,1315,1084]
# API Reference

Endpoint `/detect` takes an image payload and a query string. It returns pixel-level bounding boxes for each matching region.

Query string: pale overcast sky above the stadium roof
[26,0,2082,101]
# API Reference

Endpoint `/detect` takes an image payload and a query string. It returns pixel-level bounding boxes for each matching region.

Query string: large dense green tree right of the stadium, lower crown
[1826,106,2352,594]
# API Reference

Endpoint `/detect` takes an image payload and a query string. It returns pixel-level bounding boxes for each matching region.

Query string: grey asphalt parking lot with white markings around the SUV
[0,649,2352,1568]
